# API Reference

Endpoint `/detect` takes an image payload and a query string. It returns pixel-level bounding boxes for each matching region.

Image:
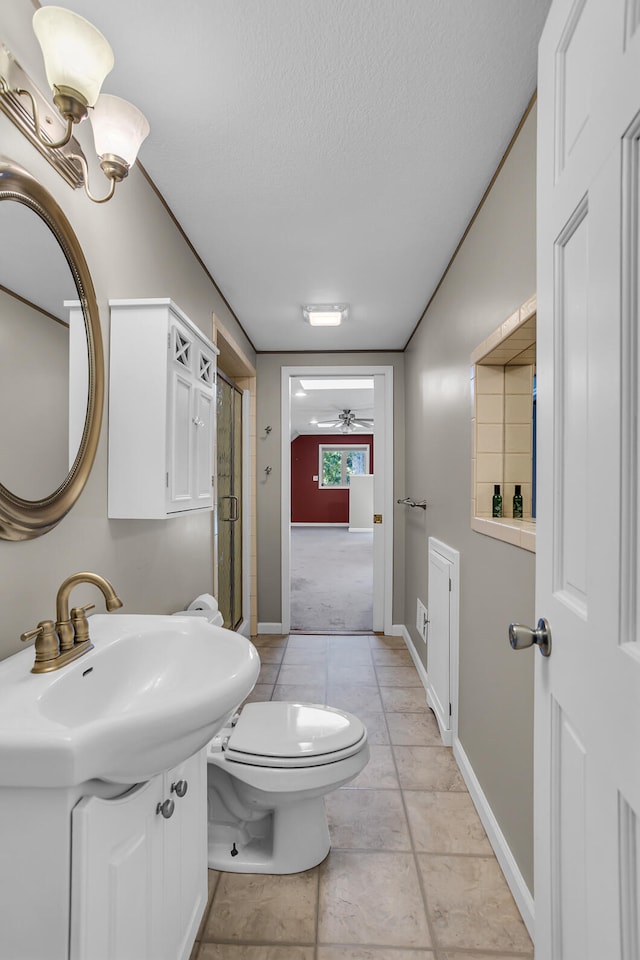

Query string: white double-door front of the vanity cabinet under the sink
[69,751,207,960]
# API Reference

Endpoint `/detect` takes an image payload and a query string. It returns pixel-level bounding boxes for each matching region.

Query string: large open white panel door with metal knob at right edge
[536,0,640,960]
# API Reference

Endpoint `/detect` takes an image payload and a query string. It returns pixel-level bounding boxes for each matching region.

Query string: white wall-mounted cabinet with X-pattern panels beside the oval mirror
[108,299,218,519]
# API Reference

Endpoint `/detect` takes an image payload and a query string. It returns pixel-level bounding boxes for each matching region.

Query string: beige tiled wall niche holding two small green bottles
[471,296,536,553]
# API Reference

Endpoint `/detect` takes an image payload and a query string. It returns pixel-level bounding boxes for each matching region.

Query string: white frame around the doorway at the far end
[280,364,394,635]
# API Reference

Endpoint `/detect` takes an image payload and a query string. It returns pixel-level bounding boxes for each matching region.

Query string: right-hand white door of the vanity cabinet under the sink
[164,750,207,960]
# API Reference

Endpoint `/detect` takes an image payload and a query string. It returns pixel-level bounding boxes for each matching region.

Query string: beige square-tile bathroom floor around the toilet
[191,635,533,960]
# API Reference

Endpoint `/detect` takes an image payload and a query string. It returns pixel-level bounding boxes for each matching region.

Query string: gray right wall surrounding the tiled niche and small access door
[404,109,536,890]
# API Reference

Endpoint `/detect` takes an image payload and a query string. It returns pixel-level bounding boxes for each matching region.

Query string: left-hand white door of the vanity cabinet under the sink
[70,777,165,960]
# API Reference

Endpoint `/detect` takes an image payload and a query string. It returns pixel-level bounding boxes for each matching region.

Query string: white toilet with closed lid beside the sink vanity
[174,598,369,874]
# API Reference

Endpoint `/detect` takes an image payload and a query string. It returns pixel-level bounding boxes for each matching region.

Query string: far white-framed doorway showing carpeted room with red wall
[282,365,393,633]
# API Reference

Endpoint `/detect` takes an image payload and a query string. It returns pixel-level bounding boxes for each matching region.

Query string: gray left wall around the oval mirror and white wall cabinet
[0,0,255,657]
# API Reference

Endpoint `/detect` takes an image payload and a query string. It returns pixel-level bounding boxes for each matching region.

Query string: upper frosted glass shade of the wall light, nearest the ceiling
[33,7,114,107]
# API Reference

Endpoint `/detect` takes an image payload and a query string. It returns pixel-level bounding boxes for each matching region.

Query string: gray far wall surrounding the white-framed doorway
[257,353,404,623]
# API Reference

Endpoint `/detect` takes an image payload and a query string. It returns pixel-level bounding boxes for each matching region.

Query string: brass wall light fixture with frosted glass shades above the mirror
[0,7,149,203]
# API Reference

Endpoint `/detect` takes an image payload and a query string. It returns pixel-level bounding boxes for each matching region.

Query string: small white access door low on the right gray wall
[427,548,452,742]
